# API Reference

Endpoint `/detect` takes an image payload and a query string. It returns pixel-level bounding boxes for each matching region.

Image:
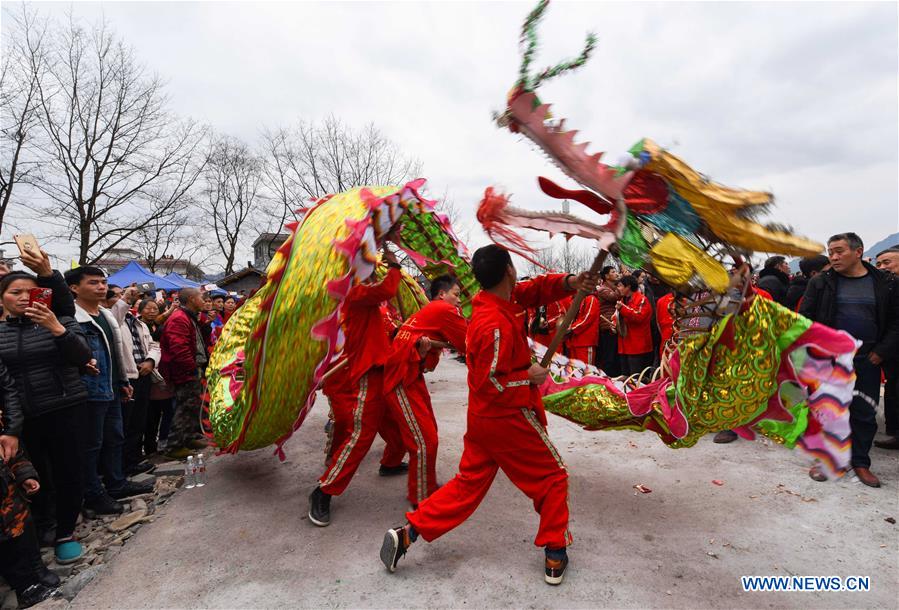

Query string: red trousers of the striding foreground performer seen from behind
[406,408,571,549]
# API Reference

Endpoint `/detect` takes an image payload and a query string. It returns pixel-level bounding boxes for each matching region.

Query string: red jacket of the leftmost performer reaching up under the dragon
[341,267,401,382]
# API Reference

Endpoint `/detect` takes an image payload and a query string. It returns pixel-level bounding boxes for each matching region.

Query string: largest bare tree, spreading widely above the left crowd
[32,16,204,264]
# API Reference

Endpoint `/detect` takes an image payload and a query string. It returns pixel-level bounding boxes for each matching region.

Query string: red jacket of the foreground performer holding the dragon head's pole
[466,274,571,422]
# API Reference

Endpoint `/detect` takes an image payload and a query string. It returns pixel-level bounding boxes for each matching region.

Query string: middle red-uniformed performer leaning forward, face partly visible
[384,275,468,507]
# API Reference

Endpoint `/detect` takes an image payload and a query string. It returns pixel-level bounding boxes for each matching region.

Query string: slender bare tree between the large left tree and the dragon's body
[203,136,262,275]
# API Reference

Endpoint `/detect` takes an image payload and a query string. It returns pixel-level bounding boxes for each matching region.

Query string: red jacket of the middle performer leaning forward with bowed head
[384,301,468,392]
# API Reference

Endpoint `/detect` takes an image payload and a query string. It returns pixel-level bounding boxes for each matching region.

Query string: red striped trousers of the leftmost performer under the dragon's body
[319,367,405,496]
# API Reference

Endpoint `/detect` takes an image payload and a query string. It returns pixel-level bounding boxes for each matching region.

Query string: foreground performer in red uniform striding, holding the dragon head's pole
[381,245,596,584]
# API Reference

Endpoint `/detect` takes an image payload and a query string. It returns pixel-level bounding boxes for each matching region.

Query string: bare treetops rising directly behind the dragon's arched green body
[262,116,421,226]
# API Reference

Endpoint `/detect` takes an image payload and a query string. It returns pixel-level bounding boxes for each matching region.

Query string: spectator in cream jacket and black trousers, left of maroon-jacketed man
[111,286,160,475]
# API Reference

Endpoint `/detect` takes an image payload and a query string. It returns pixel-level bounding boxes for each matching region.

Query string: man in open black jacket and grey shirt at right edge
[799,233,899,487]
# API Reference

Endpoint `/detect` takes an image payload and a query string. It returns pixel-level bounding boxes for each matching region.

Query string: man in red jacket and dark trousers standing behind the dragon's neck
[615,275,653,375]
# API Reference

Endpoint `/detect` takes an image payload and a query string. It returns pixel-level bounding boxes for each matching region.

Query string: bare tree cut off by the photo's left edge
[0,3,47,230]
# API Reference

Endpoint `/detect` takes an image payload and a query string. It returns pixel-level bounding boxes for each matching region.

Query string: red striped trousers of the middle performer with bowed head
[384,374,438,506]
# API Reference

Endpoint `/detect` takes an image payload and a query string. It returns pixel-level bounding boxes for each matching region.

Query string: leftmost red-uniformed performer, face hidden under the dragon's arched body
[309,249,401,527]
